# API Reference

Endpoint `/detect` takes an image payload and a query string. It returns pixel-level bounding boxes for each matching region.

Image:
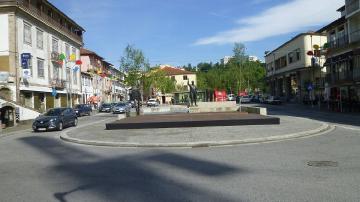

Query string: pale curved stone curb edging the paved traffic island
[60,120,335,148]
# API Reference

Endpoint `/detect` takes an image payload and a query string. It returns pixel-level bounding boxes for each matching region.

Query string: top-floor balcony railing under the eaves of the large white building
[17,0,83,43]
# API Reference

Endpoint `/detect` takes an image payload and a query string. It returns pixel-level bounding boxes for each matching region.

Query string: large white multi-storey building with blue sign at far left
[0,0,85,128]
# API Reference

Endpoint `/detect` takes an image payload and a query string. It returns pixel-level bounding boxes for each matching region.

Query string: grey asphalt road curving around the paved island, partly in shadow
[0,107,360,202]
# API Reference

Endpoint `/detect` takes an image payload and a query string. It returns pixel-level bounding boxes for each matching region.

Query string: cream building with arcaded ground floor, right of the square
[265,32,327,102]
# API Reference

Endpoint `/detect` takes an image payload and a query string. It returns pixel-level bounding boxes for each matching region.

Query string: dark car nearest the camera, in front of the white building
[32,108,78,132]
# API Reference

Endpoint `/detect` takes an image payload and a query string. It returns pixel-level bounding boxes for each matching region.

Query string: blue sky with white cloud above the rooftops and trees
[50,0,345,66]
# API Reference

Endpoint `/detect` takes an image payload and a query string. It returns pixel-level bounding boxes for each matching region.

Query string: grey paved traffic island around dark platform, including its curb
[61,116,332,147]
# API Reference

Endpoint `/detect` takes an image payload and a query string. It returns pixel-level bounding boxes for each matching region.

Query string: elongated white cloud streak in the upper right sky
[195,0,344,45]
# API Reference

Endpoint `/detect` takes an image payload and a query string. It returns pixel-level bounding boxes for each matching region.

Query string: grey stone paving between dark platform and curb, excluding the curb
[67,115,323,144]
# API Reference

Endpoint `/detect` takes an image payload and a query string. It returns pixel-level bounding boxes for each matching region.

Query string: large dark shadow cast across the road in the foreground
[20,137,246,202]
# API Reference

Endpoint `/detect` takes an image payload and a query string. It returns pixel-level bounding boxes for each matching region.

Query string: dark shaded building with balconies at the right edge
[319,0,360,112]
